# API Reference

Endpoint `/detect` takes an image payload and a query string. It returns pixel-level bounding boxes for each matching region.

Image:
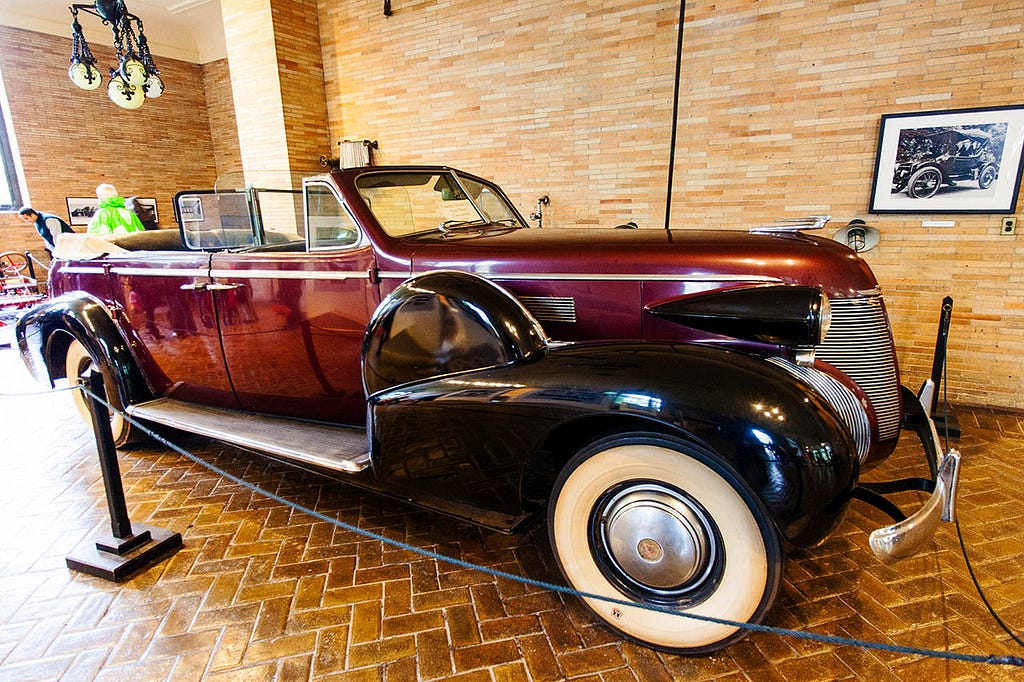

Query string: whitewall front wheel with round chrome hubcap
[548,433,782,654]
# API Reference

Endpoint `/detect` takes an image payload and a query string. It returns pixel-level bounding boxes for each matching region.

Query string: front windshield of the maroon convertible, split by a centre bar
[355,171,525,237]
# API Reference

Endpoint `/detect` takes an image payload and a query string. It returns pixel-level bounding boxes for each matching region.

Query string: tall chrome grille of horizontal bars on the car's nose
[814,295,900,439]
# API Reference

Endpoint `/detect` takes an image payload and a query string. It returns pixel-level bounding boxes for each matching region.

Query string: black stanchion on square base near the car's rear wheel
[67,372,182,583]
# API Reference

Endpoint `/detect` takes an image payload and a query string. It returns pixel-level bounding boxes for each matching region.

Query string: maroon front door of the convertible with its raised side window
[211,182,380,424]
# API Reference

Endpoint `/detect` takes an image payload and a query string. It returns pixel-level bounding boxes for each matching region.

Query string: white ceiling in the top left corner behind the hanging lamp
[0,0,225,63]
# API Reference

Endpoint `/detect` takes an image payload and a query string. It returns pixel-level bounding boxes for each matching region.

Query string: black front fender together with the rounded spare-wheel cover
[364,272,859,546]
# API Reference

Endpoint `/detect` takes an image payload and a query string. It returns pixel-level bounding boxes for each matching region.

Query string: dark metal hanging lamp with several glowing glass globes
[68,0,164,109]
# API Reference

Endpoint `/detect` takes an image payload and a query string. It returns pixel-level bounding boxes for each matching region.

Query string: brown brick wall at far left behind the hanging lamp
[0,27,226,260]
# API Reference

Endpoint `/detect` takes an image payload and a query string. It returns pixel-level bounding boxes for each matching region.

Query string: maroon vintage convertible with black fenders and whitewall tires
[16,167,957,653]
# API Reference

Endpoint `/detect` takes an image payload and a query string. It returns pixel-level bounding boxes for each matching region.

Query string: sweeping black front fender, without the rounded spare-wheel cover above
[371,343,859,546]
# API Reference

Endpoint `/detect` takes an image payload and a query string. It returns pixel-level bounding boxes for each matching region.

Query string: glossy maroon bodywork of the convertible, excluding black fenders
[51,167,900,463]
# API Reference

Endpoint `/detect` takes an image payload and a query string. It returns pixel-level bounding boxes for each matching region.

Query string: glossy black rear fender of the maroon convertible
[14,292,153,406]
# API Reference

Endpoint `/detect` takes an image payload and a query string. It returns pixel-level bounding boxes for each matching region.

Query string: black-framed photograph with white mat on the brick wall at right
[870,104,1024,213]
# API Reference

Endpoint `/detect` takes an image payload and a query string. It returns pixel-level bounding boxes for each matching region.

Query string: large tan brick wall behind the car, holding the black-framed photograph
[319,0,1024,408]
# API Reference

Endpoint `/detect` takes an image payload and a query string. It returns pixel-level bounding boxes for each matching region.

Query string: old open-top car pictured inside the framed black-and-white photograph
[892,123,1007,199]
